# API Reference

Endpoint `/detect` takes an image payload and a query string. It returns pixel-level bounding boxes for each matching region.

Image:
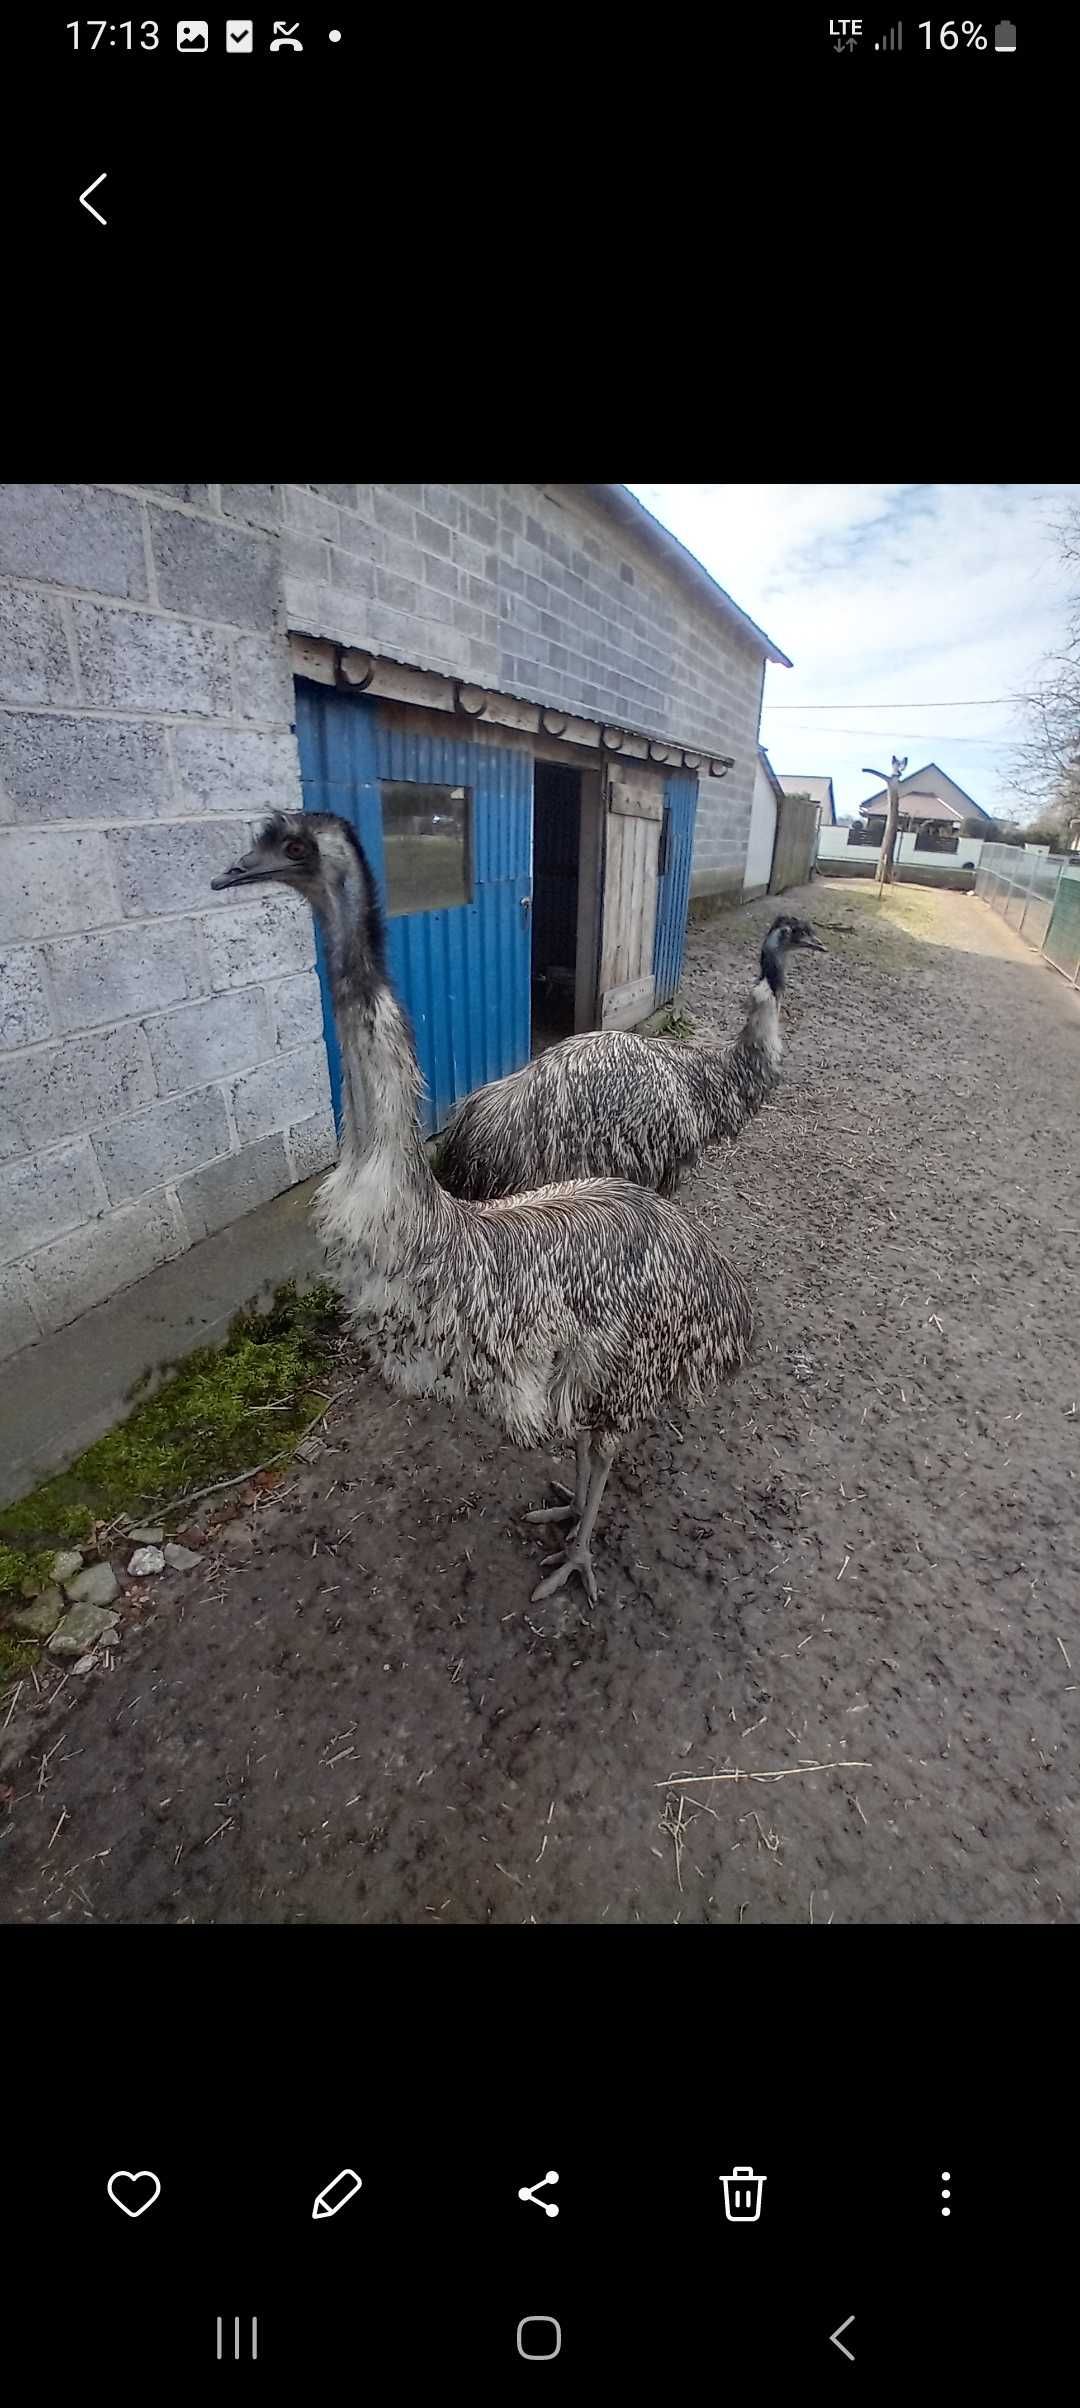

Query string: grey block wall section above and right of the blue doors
[284,484,765,896]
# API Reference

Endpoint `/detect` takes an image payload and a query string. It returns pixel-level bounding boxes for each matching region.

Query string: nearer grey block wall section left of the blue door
[0,484,334,1356]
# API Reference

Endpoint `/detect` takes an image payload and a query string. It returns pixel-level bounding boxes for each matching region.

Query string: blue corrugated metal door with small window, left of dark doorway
[296,684,532,1132]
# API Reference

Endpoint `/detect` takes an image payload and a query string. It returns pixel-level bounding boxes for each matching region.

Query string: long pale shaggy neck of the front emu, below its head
[318,872,433,1190]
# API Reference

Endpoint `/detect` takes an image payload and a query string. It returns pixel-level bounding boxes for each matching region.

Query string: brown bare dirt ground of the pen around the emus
[0,881,1080,1924]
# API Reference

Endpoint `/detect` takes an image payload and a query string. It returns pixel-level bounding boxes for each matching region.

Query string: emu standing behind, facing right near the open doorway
[438,913,825,1202]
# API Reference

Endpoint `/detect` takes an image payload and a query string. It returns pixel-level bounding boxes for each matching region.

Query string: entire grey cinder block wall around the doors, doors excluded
[0,484,762,1356]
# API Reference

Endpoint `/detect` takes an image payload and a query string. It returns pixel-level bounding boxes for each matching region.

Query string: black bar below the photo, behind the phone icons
[2,1931,1078,2398]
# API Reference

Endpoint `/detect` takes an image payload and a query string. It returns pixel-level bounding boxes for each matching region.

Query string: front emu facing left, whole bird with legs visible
[212,811,753,1597]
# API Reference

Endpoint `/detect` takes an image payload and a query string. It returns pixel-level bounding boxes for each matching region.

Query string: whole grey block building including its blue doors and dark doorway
[0,484,784,1356]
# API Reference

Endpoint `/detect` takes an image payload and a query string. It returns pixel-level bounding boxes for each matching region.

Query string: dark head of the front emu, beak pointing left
[209,811,385,973]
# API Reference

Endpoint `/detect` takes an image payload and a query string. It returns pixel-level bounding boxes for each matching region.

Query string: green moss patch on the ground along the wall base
[0,1283,342,1560]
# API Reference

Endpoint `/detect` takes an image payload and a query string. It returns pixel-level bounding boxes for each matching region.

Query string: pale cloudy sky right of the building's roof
[630,484,1080,819]
